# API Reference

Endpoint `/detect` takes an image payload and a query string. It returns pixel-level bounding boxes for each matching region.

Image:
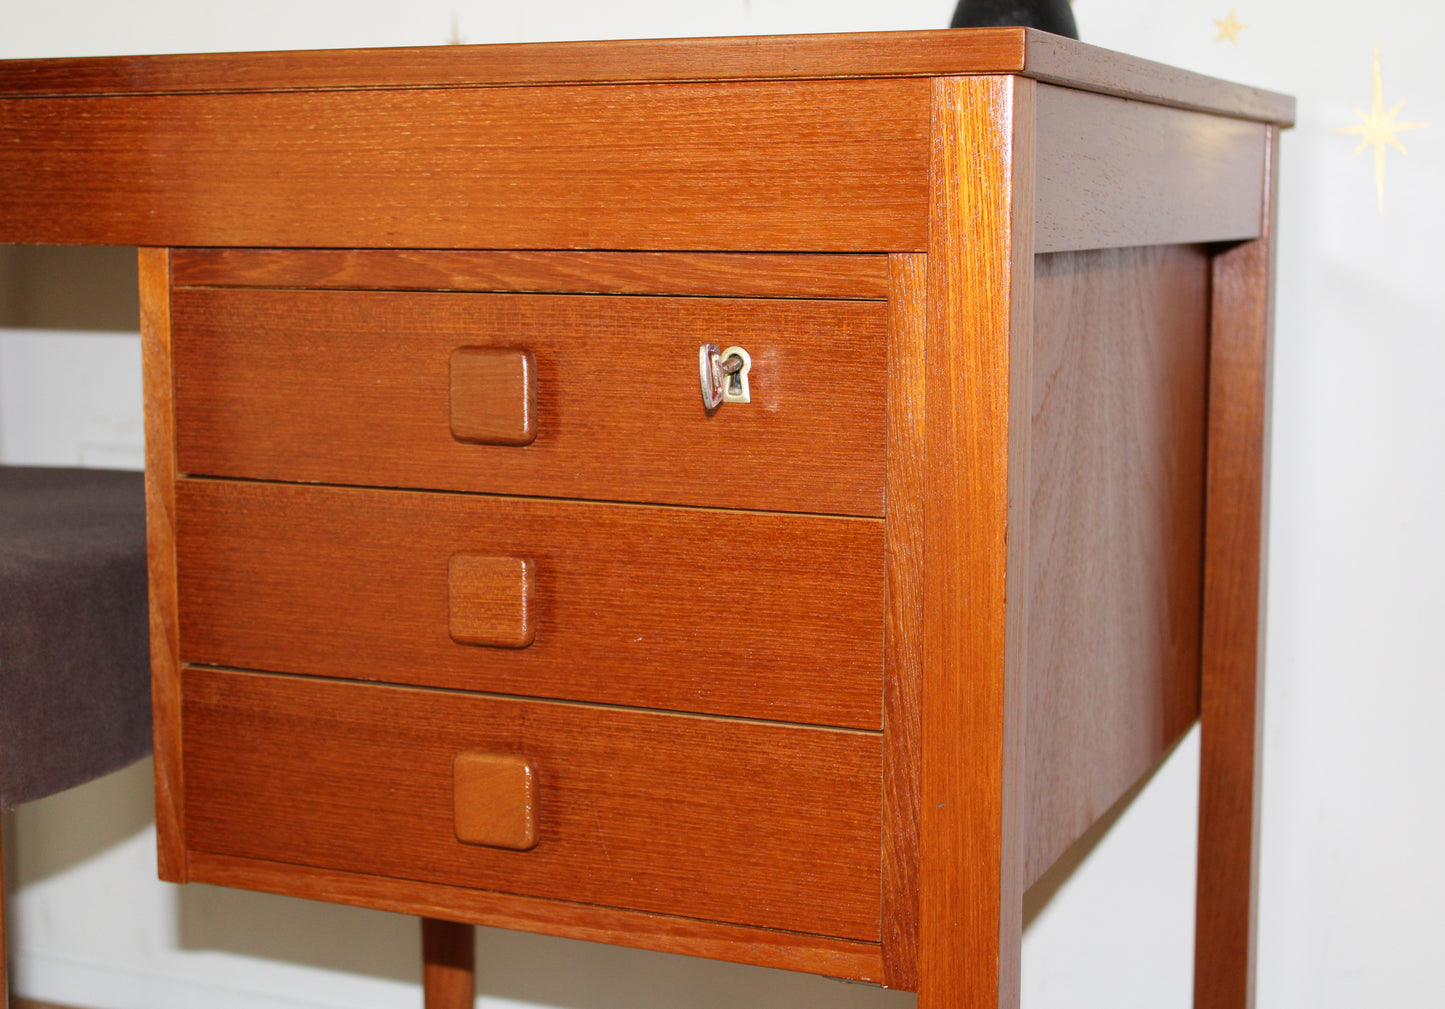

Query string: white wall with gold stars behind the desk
[0,0,1445,1009]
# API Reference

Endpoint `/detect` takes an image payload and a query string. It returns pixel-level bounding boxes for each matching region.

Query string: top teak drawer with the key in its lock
[171,288,887,516]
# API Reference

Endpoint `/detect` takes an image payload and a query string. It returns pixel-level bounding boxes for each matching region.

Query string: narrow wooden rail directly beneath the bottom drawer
[180,851,881,983]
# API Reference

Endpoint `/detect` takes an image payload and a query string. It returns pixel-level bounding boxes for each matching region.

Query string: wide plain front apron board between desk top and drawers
[0,80,928,252]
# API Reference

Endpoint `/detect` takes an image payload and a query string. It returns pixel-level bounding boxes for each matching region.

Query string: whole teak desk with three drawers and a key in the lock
[0,29,1293,1009]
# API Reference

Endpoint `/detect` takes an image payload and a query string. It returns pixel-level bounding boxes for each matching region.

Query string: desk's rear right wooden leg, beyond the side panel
[1195,130,1279,1009]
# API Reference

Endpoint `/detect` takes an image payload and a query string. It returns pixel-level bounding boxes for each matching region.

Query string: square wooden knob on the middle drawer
[447,554,536,648]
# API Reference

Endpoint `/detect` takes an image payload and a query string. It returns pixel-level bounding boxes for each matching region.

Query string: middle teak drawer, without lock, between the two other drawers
[176,478,884,729]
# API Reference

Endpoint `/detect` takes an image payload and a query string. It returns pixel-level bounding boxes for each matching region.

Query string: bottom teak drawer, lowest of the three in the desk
[182,669,881,941]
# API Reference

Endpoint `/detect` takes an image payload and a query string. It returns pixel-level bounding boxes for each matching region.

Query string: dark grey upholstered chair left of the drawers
[0,465,150,1006]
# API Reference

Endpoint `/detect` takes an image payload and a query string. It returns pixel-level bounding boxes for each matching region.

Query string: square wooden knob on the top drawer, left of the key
[451,347,538,445]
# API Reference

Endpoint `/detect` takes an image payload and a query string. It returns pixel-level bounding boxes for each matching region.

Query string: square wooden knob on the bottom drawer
[452,752,538,851]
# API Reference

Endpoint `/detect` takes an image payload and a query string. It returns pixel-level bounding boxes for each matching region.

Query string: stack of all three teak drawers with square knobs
[158,250,889,977]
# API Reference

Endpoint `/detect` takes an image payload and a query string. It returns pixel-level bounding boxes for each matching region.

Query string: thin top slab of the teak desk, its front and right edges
[0,27,1295,126]
